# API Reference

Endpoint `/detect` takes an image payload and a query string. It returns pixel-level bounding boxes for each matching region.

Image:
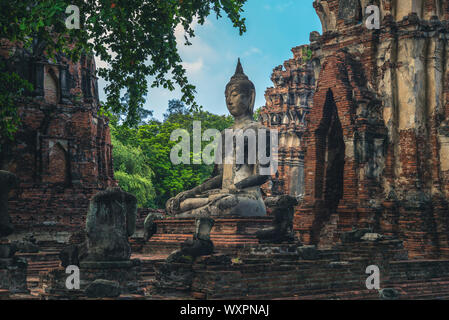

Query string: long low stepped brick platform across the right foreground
[152,241,449,300]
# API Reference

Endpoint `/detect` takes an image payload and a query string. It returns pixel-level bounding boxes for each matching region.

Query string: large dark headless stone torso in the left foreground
[86,188,137,261]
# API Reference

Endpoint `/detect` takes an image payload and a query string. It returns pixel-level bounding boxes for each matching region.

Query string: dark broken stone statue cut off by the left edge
[0,170,17,237]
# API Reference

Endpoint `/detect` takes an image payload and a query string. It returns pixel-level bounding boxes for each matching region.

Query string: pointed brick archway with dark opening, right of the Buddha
[295,50,387,247]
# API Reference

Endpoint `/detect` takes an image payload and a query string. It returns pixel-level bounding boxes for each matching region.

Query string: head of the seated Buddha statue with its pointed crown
[225,59,256,117]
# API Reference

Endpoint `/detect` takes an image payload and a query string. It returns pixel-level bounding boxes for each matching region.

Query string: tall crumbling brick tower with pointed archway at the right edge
[284,0,449,258]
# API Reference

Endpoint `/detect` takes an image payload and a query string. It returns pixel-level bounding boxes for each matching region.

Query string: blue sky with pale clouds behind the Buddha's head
[99,0,321,119]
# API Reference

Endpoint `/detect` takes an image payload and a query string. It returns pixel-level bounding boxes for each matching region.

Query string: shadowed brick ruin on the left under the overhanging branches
[0,41,116,241]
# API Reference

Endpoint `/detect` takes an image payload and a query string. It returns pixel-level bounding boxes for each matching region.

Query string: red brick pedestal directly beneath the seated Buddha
[142,217,273,254]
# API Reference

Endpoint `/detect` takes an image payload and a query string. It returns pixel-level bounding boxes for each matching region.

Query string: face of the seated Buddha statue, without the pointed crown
[226,84,254,117]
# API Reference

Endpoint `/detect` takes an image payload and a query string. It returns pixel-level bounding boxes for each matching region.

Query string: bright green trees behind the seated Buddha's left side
[111,100,233,207]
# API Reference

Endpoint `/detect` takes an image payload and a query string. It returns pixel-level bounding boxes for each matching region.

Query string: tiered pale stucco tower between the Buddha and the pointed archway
[259,45,315,197]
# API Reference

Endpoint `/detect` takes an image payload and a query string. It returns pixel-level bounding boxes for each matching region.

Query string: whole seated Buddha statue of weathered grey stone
[166,59,270,217]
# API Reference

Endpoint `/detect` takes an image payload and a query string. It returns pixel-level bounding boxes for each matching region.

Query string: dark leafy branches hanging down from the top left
[0,0,246,134]
